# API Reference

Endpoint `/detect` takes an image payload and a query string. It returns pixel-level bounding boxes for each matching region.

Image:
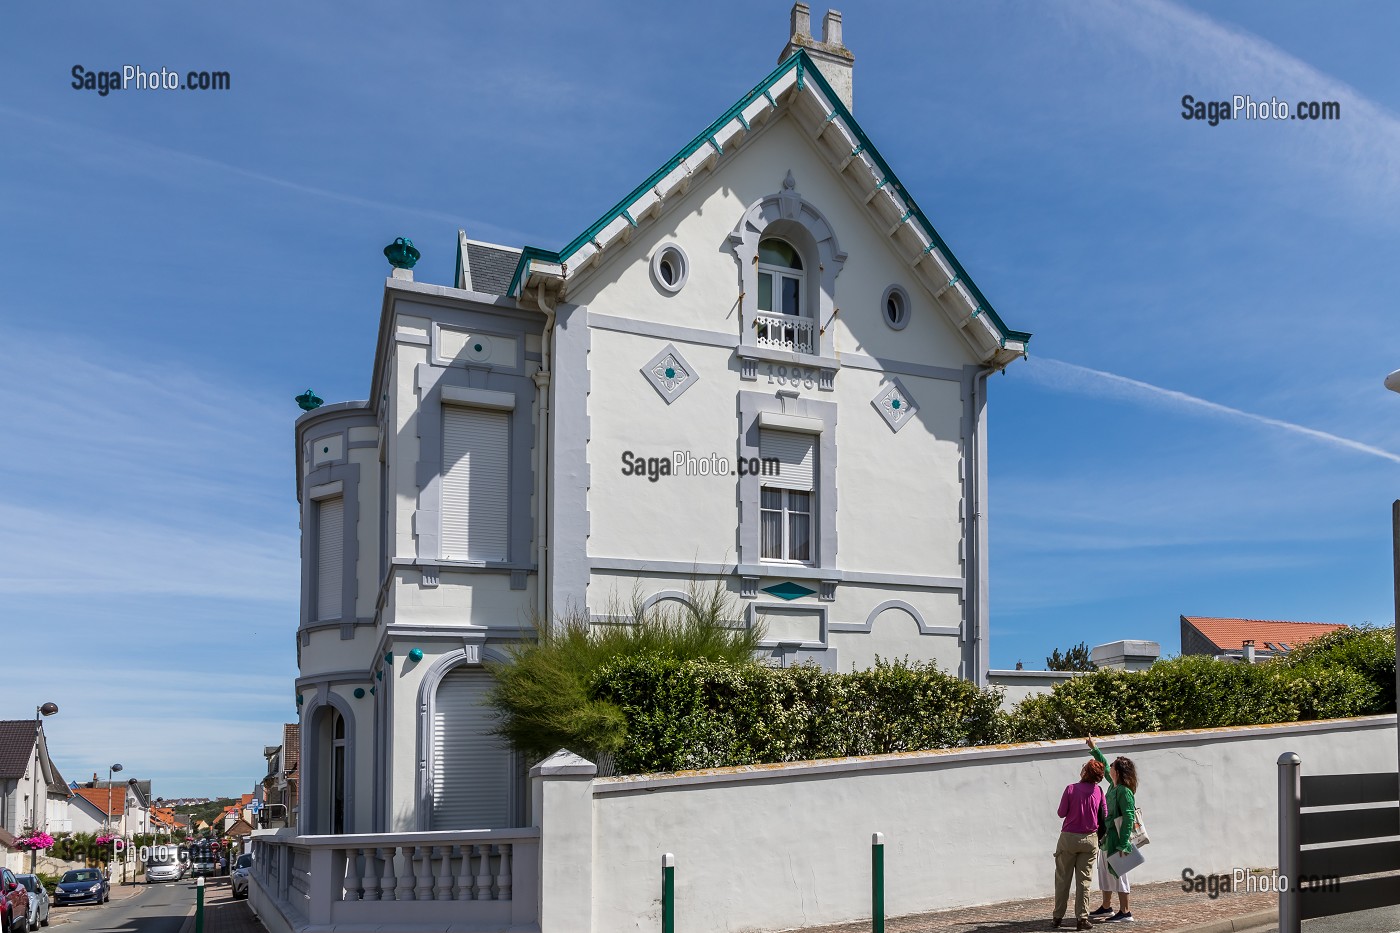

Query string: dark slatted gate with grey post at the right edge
[1278,752,1400,933]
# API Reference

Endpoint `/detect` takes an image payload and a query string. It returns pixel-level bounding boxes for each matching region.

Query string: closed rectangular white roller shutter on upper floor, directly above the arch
[442,405,511,560]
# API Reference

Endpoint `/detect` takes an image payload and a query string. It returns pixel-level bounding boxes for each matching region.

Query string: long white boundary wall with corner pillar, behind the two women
[532,716,1396,933]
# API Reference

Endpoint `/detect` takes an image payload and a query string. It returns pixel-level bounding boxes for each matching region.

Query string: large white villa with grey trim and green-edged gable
[295,3,1029,834]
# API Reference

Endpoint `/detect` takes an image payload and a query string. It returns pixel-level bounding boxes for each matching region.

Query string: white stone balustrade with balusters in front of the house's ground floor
[252,829,539,933]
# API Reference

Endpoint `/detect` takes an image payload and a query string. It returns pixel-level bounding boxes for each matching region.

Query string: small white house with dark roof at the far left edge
[0,719,71,870]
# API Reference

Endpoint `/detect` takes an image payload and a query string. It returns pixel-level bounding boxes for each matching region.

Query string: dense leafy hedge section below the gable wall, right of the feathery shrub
[591,657,1004,773]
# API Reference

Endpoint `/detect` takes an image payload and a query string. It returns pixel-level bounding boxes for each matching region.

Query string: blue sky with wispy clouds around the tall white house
[0,1,1400,796]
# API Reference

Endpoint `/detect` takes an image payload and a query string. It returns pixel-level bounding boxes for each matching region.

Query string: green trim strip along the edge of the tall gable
[507,49,1030,346]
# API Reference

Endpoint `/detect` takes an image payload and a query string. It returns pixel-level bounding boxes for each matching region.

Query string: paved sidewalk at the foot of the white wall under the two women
[802,881,1278,933]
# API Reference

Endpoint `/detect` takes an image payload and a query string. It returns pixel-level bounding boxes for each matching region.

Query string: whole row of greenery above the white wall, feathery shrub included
[493,616,1396,773]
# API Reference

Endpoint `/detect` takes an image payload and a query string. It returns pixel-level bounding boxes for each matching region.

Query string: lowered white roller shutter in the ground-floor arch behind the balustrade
[433,667,511,829]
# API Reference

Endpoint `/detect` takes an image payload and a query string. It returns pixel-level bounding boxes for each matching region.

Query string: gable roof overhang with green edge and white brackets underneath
[509,49,1030,367]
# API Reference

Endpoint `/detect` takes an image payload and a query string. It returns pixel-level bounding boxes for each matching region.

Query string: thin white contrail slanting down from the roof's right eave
[1025,357,1400,464]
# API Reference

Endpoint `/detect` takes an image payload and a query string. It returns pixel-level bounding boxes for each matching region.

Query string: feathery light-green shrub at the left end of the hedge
[489,581,763,758]
